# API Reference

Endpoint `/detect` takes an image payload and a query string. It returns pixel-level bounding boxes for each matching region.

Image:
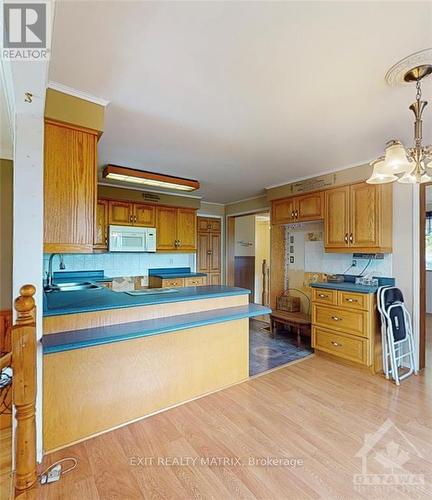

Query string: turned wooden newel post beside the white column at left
[12,285,37,490]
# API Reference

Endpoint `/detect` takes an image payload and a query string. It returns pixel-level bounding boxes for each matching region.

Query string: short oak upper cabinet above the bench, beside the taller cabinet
[272,191,323,224]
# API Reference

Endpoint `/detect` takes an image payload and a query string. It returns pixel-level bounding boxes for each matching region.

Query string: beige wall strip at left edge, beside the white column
[0,159,13,310]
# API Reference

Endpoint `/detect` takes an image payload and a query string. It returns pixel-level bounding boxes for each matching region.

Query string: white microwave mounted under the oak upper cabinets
[108,226,156,252]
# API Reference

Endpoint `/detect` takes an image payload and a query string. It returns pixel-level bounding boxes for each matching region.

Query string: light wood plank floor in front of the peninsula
[38,357,432,500]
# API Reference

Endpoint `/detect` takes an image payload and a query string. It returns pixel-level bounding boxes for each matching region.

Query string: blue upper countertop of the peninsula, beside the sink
[43,285,251,316]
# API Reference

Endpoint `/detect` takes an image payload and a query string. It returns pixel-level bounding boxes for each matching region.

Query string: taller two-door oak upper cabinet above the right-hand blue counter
[324,183,393,253]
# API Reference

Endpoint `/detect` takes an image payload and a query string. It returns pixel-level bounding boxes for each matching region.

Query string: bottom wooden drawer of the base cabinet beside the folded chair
[312,327,368,365]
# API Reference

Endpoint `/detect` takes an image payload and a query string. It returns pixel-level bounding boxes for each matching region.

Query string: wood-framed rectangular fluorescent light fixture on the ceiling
[103,165,200,191]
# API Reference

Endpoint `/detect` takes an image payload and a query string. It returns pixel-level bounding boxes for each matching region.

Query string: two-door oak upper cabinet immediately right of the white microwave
[156,207,196,252]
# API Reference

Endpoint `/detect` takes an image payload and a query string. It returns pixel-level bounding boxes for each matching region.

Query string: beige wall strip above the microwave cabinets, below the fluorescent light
[98,185,201,209]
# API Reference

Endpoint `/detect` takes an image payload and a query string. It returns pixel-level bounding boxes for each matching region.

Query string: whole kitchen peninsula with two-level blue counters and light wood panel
[42,286,270,452]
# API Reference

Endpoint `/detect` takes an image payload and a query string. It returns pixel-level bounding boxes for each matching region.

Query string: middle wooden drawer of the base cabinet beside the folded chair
[312,304,369,337]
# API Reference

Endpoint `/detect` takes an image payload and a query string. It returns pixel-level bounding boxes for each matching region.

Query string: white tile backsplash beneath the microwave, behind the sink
[43,252,195,278]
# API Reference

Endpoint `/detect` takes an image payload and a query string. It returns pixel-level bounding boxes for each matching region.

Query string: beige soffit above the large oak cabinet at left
[45,89,105,132]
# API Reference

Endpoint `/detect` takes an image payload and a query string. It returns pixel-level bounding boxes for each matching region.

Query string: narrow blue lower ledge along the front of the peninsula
[42,302,271,354]
